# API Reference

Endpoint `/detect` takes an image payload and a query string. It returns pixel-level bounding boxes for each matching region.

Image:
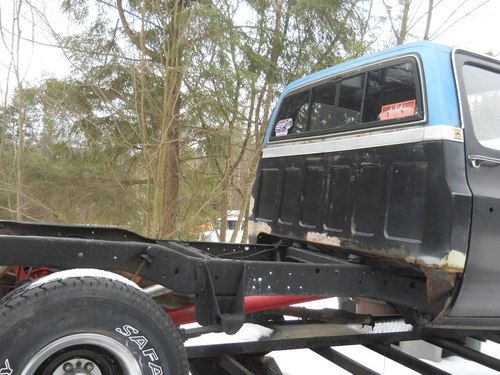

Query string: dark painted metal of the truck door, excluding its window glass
[449,52,500,325]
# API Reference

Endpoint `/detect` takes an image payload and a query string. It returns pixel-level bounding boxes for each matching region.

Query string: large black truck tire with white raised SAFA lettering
[0,277,188,375]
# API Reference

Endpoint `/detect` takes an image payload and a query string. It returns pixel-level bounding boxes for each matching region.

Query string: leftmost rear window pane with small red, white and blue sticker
[274,90,310,137]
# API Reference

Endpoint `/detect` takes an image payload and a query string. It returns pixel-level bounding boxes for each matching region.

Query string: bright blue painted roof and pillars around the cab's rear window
[265,41,460,143]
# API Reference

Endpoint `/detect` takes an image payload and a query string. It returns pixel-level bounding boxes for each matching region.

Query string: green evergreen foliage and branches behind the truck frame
[0,0,372,238]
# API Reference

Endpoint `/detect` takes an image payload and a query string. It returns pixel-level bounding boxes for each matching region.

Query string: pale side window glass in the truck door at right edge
[463,65,500,150]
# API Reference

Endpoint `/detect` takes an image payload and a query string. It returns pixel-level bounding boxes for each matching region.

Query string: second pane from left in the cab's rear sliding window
[309,83,335,131]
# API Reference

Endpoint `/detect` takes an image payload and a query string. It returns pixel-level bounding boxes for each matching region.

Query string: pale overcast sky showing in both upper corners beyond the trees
[0,0,500,93]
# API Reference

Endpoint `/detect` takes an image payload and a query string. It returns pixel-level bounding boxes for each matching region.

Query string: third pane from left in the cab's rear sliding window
[335,74,365,128]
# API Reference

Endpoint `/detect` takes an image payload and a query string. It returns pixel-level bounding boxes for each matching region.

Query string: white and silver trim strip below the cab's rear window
[262,125,464,159]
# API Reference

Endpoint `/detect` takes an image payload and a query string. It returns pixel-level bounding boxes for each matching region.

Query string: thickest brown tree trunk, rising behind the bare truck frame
[116,0,184,238]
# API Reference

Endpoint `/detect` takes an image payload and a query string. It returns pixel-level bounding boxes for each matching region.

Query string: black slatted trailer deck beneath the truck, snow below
[186,320,500,375]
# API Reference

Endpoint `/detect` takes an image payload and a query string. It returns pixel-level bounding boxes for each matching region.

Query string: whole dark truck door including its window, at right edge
[451,51,500,317]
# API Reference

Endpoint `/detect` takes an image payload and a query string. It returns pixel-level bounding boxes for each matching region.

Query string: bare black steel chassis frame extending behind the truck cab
[0,221,446,333]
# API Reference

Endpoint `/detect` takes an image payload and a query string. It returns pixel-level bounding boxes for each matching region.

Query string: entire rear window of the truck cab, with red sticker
[272,57,423,140]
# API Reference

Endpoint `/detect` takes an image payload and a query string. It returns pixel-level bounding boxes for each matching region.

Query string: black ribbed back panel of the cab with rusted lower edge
[253,141,471,272]
